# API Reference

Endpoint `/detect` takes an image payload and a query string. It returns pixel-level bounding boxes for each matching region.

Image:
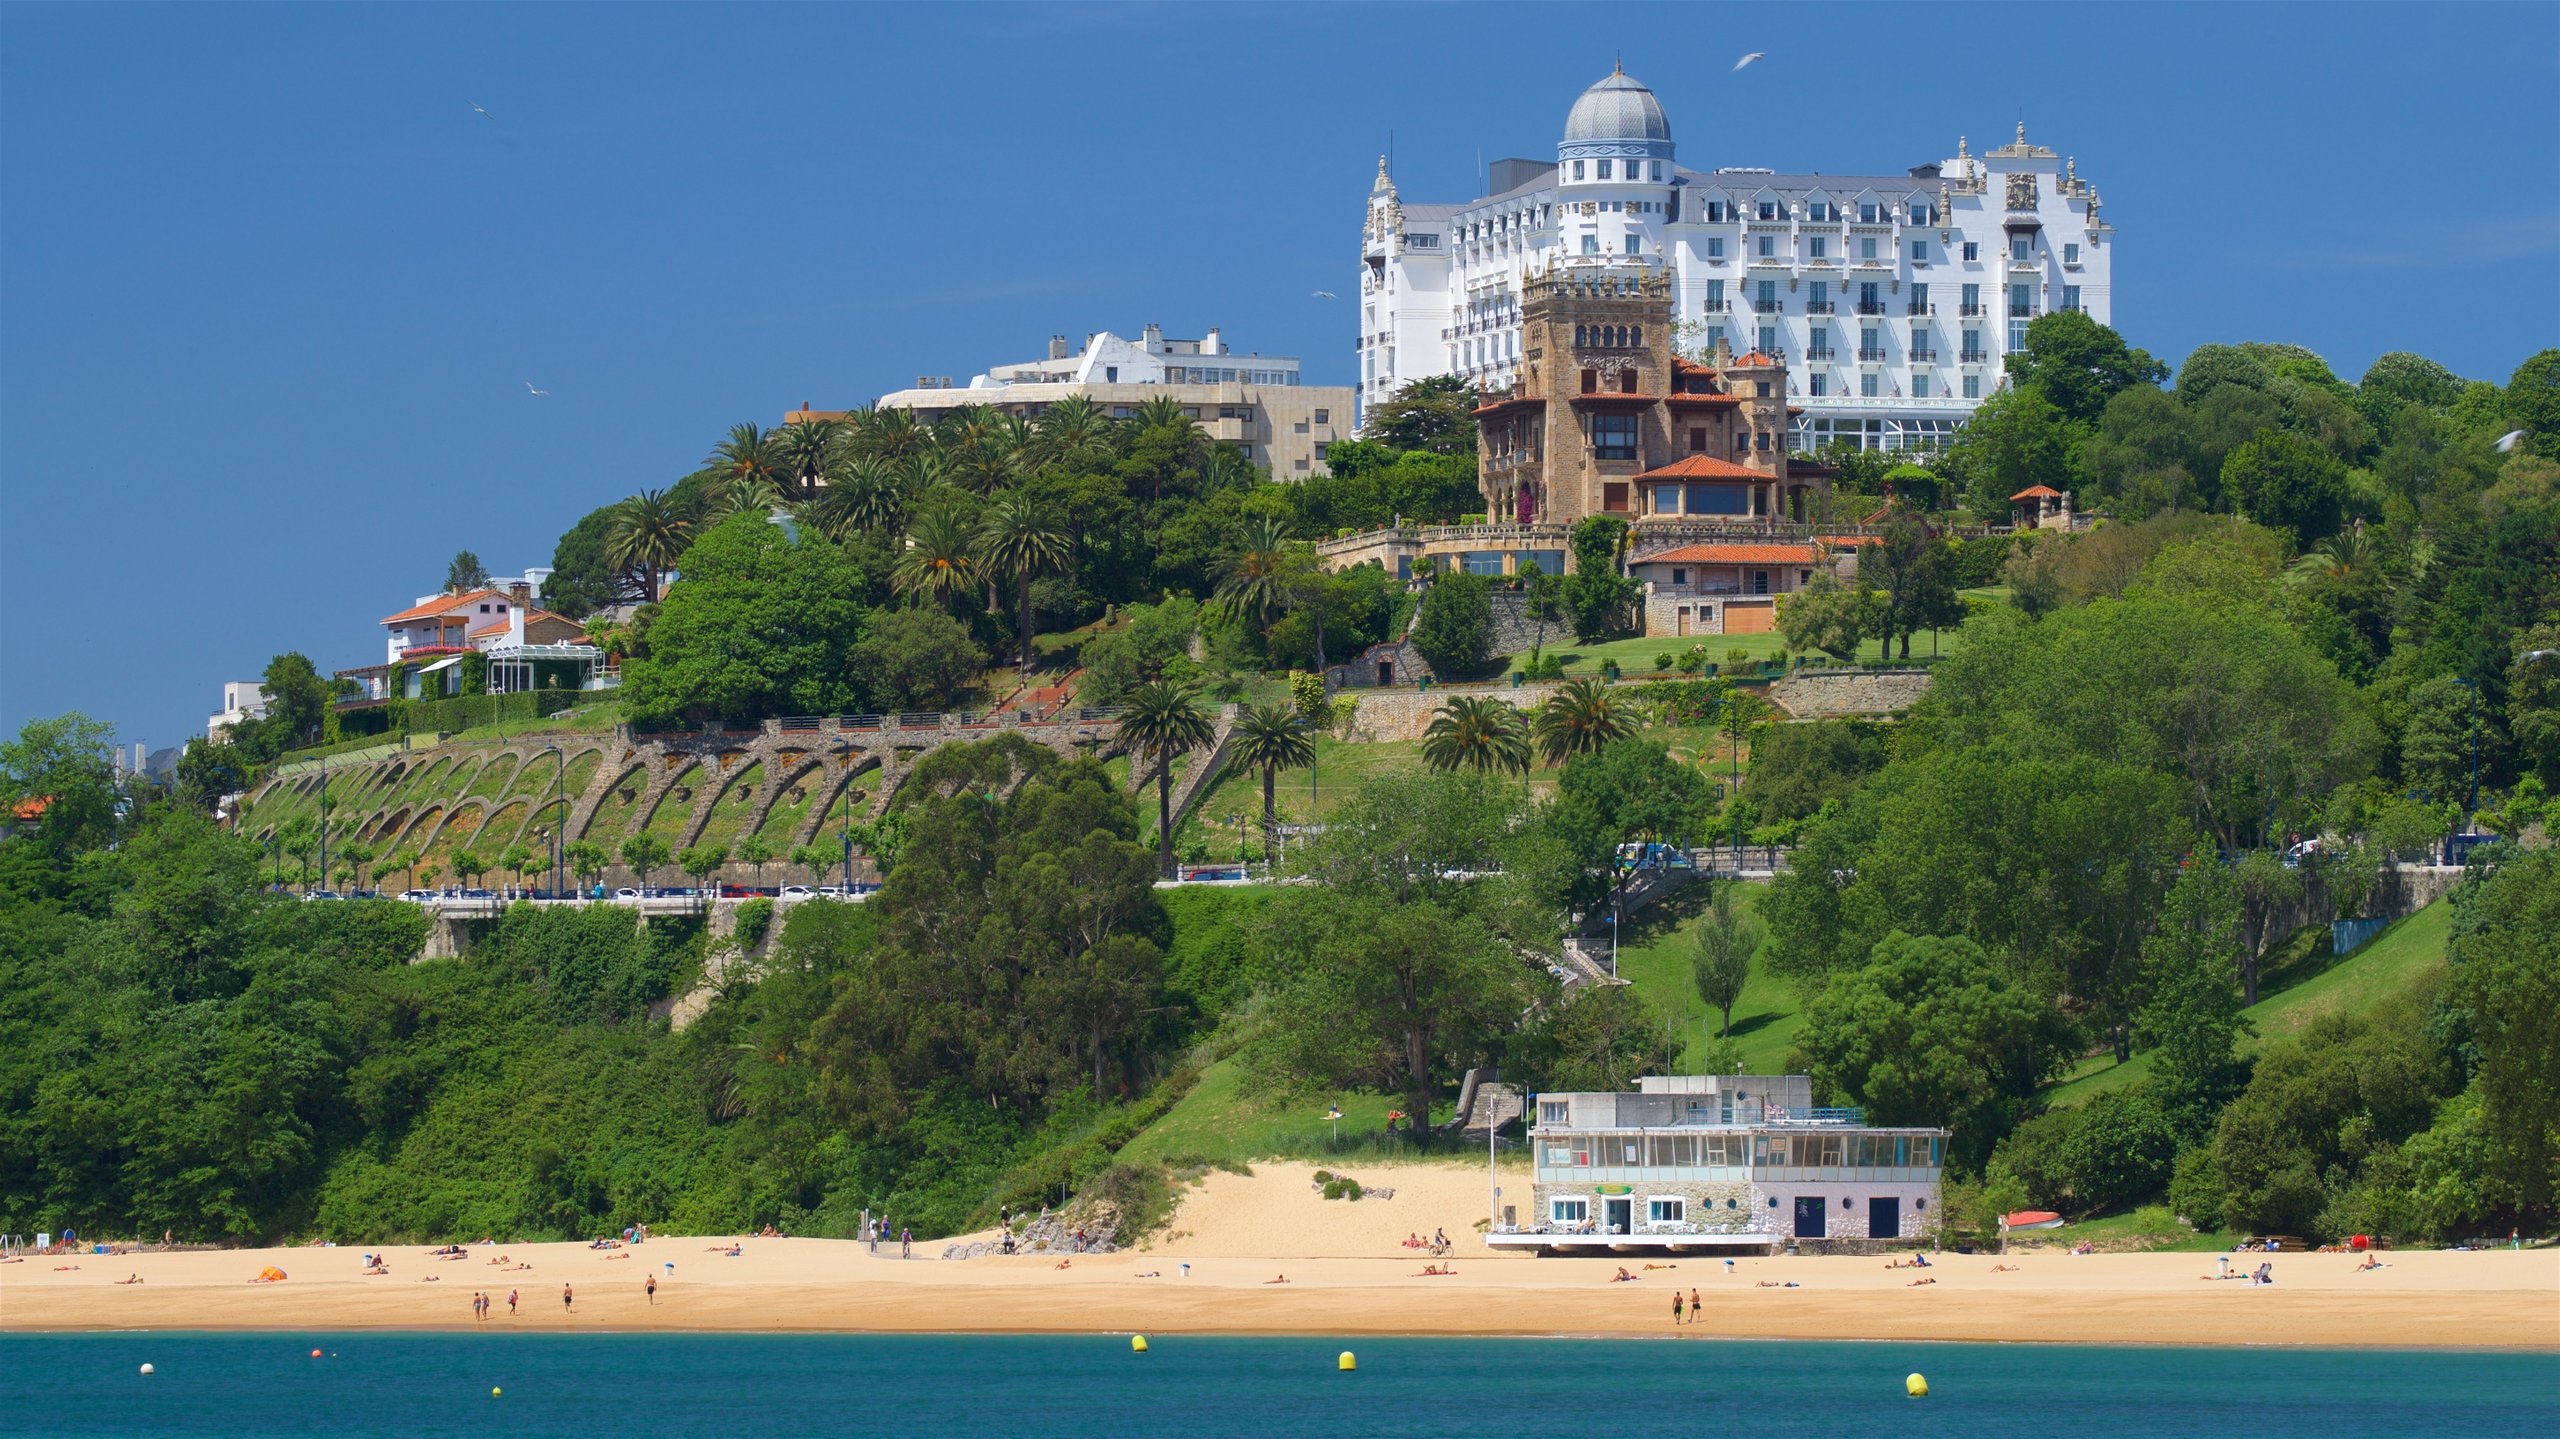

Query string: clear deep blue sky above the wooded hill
[0,5,2560,745]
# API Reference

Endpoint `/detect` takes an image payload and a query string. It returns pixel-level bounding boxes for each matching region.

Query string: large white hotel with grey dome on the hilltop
[1359,72,2115,451]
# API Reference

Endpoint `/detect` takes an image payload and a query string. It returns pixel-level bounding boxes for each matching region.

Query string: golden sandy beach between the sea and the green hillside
[0,1165,2560,1349]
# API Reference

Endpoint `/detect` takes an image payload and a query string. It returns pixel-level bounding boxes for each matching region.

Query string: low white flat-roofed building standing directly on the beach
[1485,1075,1948,1252]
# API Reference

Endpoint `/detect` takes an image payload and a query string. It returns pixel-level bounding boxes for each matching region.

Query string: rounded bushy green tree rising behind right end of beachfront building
[1789,929,2068,1170]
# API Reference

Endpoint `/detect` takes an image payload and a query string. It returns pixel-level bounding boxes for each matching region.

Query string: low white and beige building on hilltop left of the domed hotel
[860,325,1357,479]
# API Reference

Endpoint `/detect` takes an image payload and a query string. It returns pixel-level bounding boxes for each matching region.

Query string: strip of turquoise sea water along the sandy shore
[0,1334,2560,1439]
